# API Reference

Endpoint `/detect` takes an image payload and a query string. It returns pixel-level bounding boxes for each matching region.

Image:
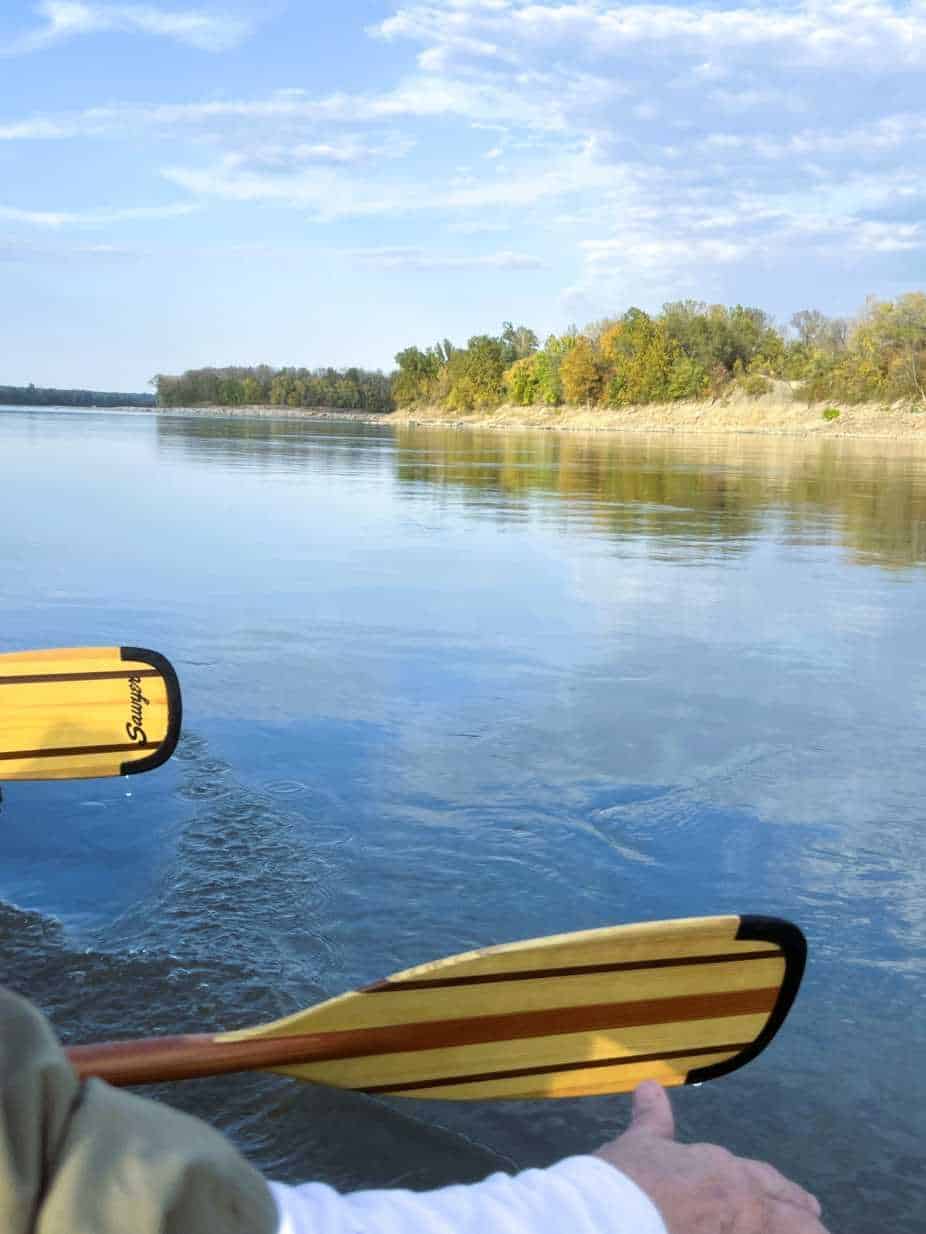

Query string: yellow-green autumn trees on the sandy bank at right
[391,291,926,411]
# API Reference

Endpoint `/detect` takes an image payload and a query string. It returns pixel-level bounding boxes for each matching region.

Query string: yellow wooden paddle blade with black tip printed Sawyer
[0,647,181,780]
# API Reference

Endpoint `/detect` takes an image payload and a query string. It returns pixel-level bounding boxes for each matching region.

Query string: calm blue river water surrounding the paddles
[0,410,926,1234]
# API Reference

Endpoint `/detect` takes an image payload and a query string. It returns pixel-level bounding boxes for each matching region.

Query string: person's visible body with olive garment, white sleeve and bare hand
[0,991,826,1234]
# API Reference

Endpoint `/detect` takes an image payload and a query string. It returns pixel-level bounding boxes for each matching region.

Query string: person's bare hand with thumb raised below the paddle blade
[595,1080,826,1234]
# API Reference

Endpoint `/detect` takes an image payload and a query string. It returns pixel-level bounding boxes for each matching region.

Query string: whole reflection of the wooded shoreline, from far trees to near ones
[157,416,926,566]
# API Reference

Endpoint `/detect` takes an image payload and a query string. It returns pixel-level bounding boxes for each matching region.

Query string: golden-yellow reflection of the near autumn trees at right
[396,428,926,566]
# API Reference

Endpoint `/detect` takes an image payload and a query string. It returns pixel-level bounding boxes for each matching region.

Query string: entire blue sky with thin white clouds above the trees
[0,0,926,390]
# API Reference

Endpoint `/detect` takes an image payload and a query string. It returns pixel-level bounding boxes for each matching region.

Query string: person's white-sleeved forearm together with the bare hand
[272,1082,826,1234]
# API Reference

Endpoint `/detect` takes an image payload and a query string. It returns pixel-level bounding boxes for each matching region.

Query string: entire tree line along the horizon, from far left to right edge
[61,291,926,412]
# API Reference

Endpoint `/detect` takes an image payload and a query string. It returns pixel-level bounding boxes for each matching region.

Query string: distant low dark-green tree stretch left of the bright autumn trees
[153,364,394,412]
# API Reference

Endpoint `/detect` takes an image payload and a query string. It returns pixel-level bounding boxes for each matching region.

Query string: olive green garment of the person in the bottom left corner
[0,990,278,1234]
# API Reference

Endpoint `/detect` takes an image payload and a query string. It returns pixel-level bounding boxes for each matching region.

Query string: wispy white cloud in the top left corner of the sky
[0,0,251,56]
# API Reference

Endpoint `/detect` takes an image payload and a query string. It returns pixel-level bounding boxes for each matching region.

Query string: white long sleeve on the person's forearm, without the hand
[270,1156,667,1234]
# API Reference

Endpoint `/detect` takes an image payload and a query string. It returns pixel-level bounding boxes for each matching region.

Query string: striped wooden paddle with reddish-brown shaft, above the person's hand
[68,917,806,1101]
